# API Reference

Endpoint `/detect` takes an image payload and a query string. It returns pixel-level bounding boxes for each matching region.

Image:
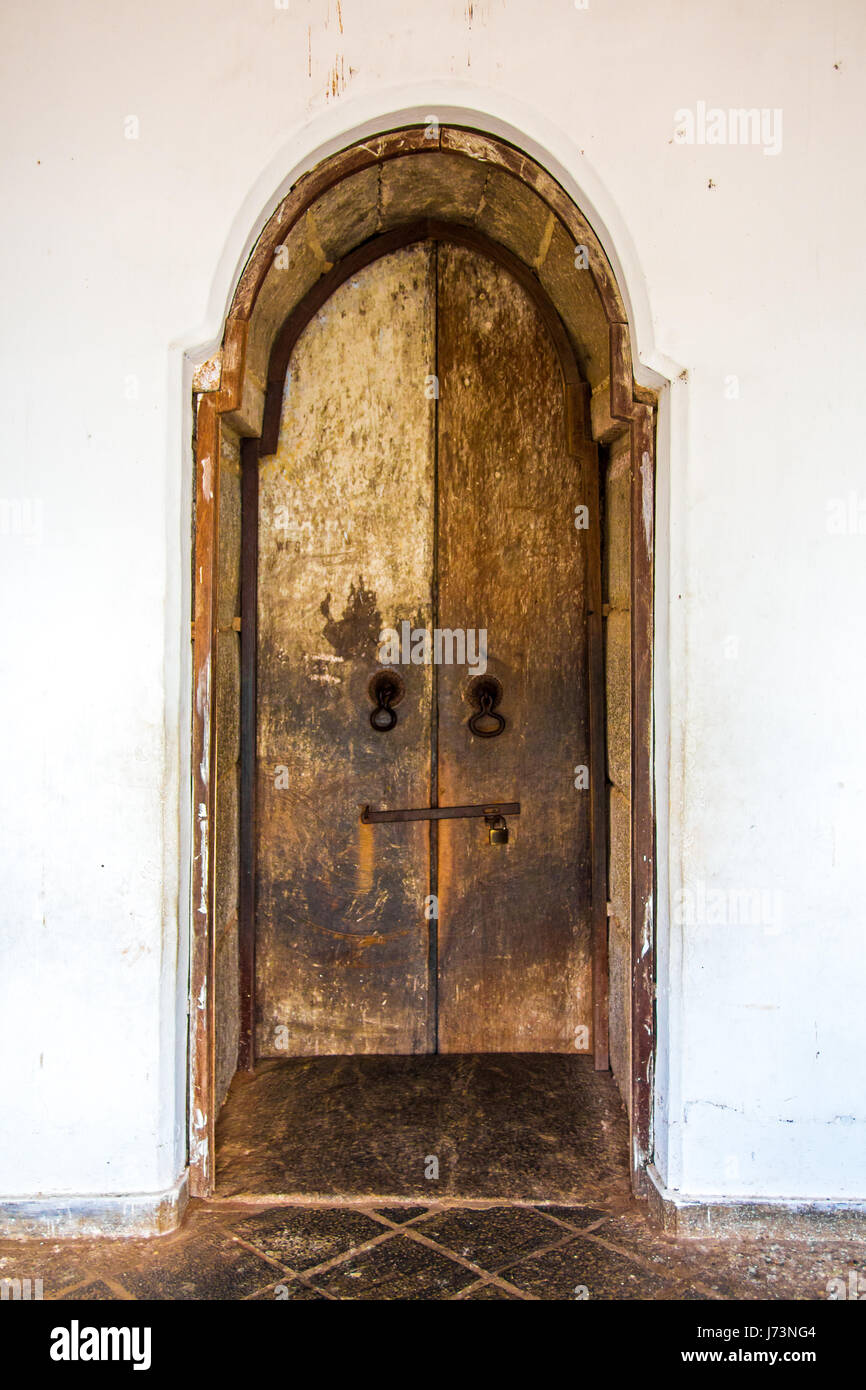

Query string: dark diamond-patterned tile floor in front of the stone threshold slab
[0,1201,866,1301]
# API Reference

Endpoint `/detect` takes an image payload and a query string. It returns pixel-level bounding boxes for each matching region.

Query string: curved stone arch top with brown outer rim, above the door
[206,125,655,450]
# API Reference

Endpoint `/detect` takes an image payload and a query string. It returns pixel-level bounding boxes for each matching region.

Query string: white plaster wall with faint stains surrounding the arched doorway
[0,0,866,1197]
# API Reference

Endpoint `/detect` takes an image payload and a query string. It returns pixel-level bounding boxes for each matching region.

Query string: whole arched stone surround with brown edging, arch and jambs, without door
[190,125,655,1195]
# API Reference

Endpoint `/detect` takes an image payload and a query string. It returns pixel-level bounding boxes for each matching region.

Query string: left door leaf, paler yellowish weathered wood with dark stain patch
[256,246,435,1056]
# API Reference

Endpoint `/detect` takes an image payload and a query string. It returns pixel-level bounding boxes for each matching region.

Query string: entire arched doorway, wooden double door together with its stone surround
[192,129,653,1191]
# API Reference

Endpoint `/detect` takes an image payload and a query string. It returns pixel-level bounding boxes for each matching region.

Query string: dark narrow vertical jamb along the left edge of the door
[238,439,259,1072]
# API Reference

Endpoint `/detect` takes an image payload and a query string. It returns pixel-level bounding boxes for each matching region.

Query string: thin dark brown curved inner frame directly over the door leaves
[259,217,588,457]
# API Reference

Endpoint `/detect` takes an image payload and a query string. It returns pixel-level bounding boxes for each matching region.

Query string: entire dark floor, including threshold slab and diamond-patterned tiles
[0,1055,866,1301]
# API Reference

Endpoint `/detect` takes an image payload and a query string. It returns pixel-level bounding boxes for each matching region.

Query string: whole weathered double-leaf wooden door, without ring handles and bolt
[256,242,592,1056]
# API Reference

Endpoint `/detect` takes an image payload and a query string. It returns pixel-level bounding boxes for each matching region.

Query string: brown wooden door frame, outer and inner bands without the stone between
[189,126,655,1195]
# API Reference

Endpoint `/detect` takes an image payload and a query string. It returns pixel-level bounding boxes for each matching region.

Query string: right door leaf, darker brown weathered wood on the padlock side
[438,245,592,1052]
